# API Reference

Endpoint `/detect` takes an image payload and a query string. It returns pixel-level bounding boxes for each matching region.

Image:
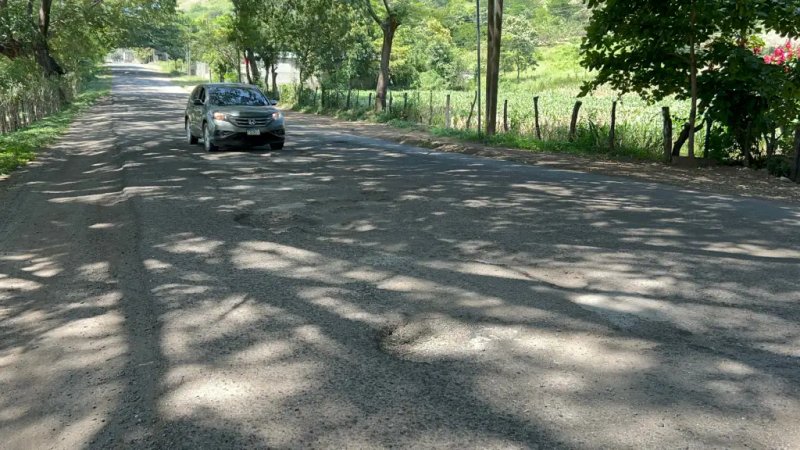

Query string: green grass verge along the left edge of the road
[0,72,111,175]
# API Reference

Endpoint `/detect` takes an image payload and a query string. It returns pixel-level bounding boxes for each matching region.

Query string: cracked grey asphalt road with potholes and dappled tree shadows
[0,66,800,449]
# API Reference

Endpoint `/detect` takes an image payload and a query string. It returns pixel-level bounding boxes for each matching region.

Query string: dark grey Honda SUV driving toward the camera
[184,83,286,152]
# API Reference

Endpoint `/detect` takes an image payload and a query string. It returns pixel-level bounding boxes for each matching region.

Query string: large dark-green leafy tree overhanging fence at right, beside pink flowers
[581,0,800,164]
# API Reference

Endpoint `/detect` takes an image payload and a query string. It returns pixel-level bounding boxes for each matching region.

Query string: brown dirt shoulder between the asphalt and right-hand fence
[289,111,800,203]
